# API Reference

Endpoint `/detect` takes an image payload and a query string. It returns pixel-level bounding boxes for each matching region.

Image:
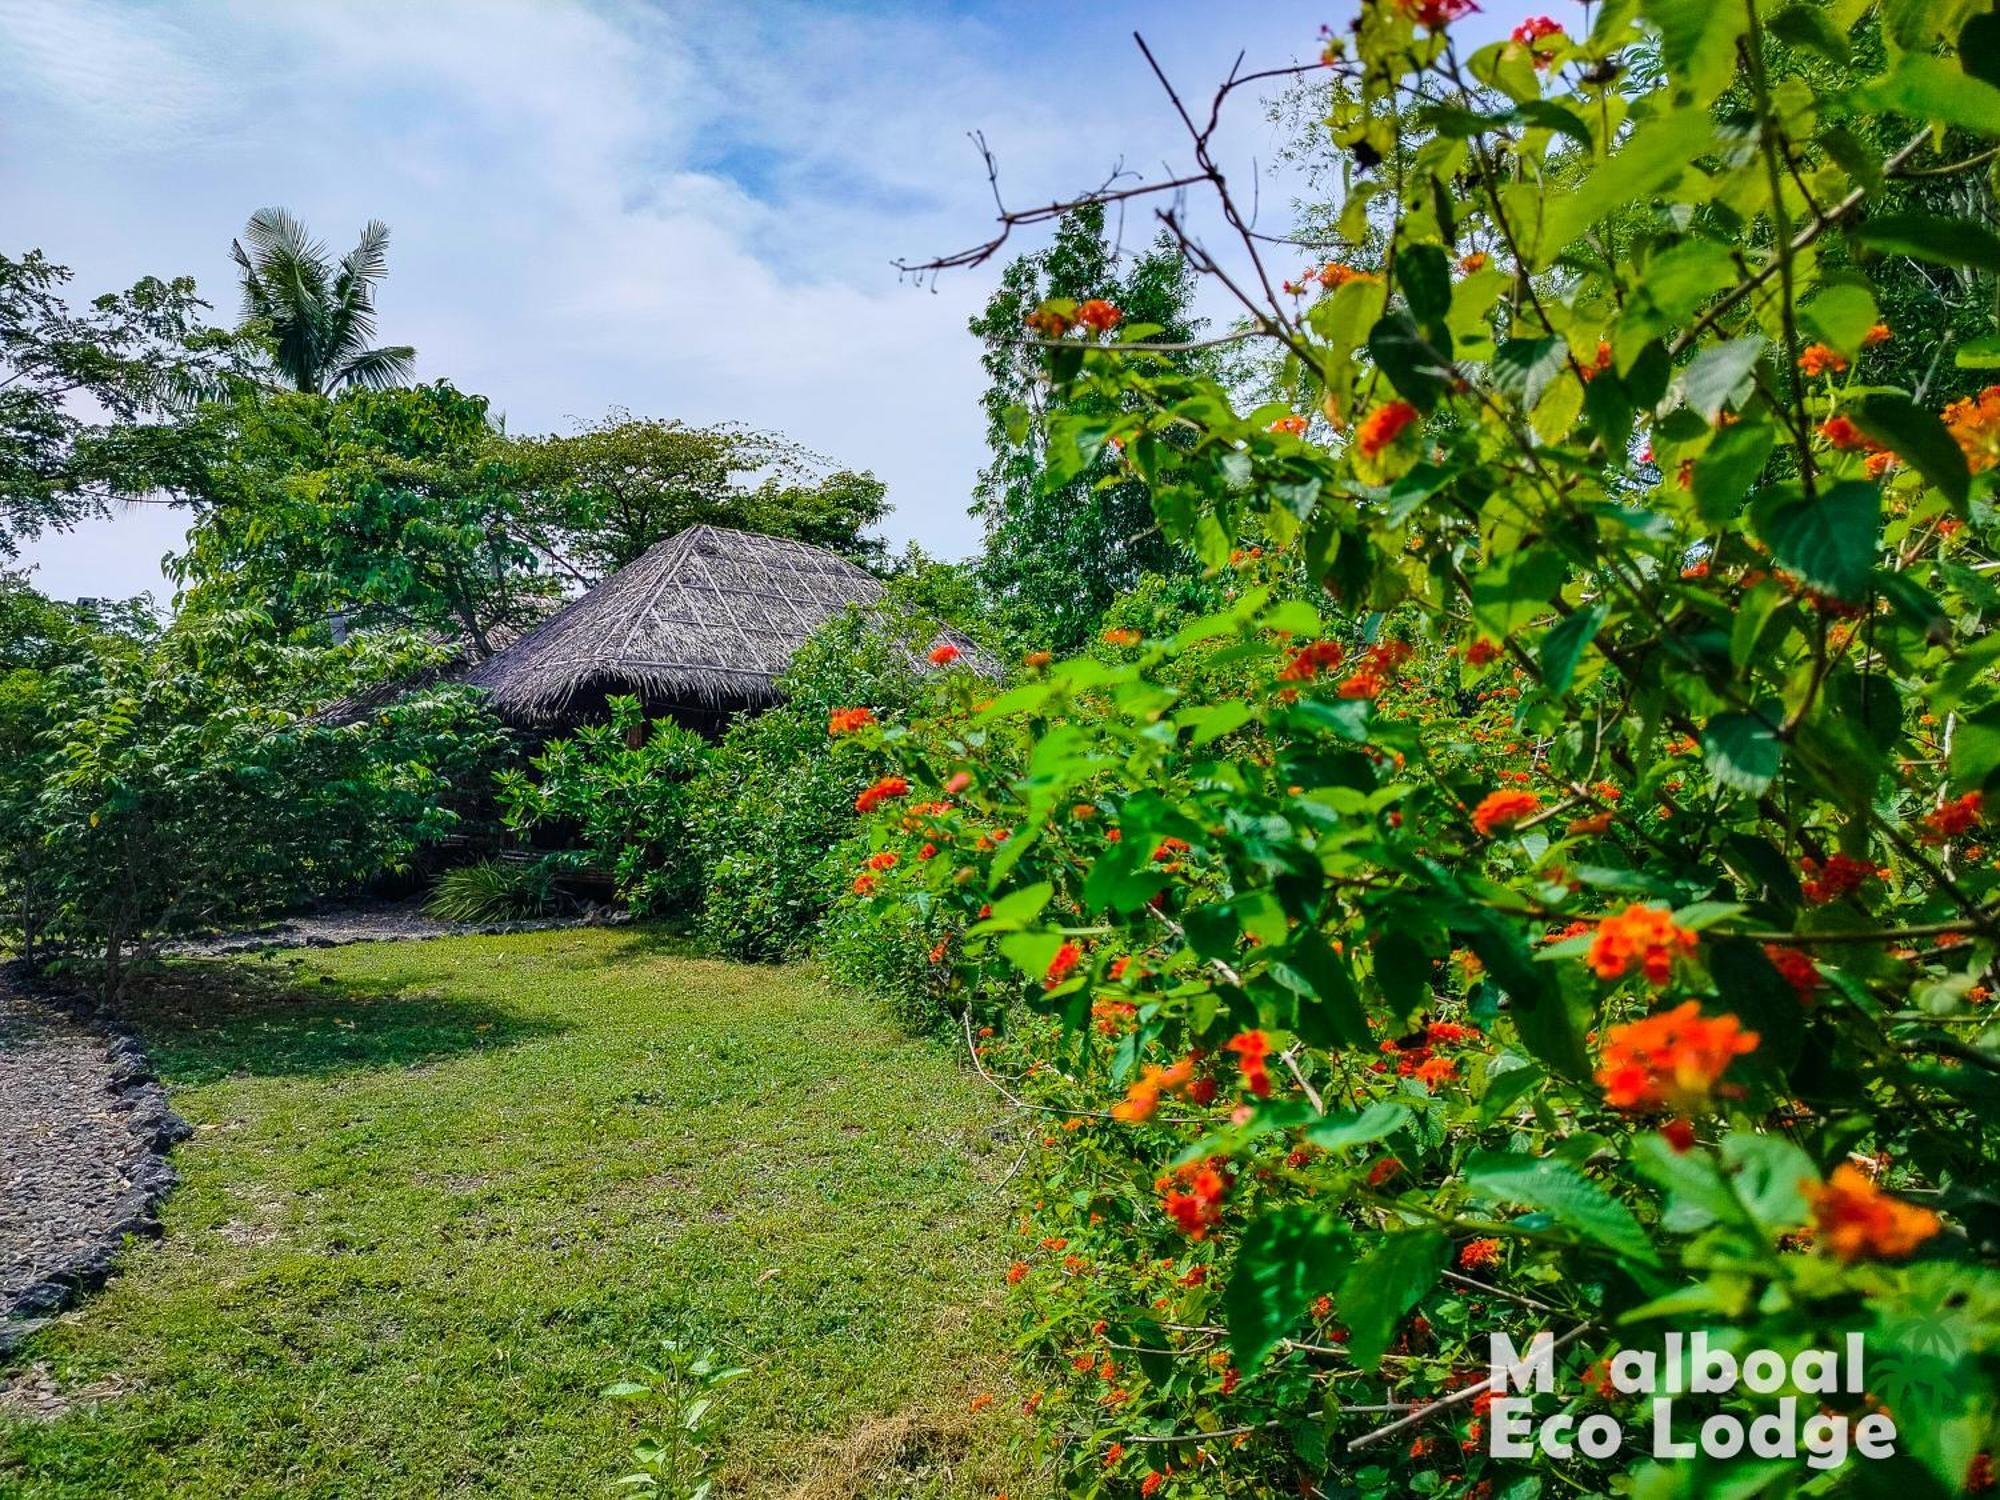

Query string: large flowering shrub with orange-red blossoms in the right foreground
[836,0,2000,1496]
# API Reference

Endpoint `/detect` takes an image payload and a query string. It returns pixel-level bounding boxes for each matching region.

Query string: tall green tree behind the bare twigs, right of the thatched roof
[970,204,1200,650]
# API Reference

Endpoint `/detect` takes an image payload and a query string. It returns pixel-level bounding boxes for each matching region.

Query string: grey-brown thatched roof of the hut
[464,526,968,724]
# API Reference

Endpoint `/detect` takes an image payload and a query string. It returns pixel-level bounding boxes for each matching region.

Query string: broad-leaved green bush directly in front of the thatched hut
[500,698,708,914]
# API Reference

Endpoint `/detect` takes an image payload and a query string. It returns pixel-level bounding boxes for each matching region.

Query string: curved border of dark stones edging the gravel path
[0,960,194,1356]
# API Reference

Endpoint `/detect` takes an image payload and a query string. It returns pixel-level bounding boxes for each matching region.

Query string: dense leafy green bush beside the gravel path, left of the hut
[16,616,504,996]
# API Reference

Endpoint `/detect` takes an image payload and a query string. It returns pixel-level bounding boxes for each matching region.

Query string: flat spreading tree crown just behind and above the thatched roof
[506,412,888,582]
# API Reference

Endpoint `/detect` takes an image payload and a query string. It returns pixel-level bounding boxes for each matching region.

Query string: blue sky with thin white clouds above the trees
[0,0,1528,596]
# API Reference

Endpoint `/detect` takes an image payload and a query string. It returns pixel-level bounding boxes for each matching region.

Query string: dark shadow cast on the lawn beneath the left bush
[124,962,568,1088]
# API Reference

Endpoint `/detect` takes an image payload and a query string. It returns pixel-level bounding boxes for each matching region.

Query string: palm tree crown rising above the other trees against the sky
[230,208,416,396]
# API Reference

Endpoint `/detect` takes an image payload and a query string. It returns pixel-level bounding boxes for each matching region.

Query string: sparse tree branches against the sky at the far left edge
[0,250,246,558]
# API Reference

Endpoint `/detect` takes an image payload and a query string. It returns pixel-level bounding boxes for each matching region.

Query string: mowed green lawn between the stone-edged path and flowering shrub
[0,928,1030,1500]
